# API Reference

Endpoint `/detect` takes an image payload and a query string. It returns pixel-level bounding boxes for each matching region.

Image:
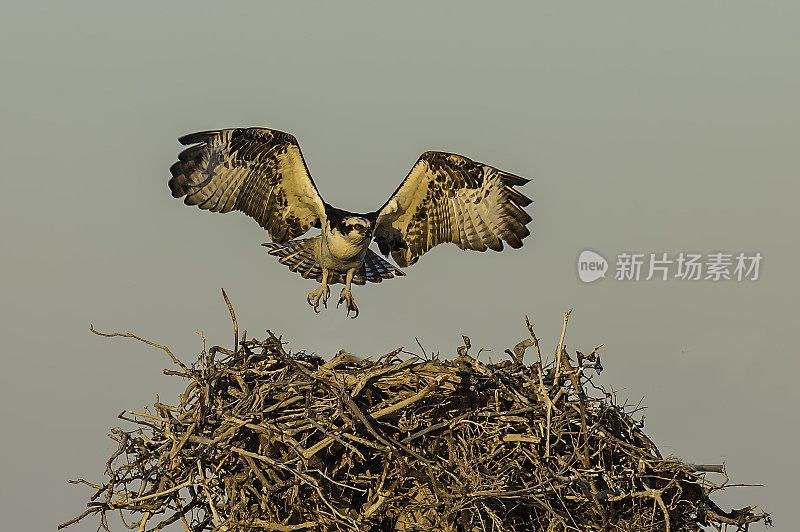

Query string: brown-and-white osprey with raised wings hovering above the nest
[169,128,531,318]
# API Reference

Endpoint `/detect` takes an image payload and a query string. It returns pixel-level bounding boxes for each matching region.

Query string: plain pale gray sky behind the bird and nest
[0,1,800,531]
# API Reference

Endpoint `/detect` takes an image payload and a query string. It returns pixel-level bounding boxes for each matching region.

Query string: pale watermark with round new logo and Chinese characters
[578,250,764,283]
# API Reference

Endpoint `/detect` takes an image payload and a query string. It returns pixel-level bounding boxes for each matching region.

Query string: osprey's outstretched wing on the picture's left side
[169,128,325,243]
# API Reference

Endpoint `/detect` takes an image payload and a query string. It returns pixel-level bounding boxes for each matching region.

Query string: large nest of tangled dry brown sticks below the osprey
[59,309,770,532]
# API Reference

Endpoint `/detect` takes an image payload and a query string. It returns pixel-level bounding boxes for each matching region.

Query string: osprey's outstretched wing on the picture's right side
[374,151,531,267]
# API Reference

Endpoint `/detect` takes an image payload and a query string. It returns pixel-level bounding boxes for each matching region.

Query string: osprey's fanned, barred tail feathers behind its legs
[262,236,405,284]
